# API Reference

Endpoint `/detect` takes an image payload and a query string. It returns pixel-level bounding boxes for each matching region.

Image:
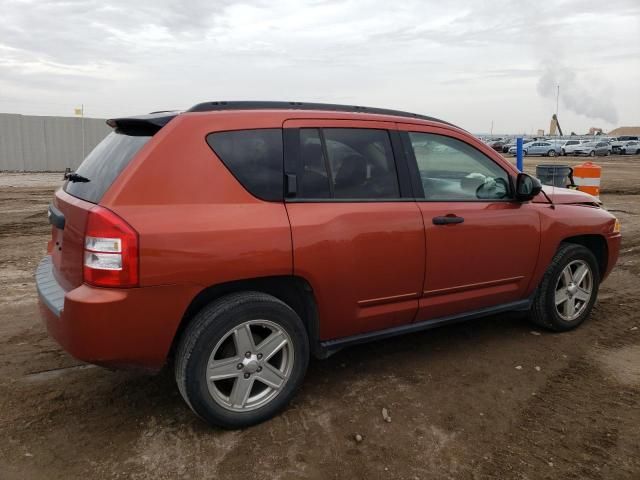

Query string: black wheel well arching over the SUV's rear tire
[169,275,320,357]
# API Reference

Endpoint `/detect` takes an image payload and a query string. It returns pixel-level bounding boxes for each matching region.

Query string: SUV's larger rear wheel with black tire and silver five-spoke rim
[175,292,309,429]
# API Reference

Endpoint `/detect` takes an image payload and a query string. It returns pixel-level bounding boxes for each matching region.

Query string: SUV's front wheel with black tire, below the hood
[530,243,600,332]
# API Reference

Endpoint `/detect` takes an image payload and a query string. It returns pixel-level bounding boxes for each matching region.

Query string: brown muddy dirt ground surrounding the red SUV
[0,156,640,480]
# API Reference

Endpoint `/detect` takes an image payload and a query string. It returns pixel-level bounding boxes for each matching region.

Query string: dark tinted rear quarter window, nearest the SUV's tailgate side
[207,128,284,201]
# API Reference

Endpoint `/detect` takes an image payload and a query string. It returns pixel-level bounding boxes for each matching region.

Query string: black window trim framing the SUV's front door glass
[399,130,516,203]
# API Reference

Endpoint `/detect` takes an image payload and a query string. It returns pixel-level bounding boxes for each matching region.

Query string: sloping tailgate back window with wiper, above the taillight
[64,132,151,203]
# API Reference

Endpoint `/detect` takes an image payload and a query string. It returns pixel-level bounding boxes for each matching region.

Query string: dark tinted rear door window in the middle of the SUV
[297,128,400,200]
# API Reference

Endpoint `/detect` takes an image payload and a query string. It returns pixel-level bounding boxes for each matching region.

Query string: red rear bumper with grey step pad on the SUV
[36,256,200,371]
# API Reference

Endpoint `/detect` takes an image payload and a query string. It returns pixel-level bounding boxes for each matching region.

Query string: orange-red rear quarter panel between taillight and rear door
[101,112,292,288]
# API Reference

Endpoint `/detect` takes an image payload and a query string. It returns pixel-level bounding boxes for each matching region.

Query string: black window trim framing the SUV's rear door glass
[283,126,415,203]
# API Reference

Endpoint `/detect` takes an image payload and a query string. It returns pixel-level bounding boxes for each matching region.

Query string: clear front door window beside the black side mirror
[409,132,510,202]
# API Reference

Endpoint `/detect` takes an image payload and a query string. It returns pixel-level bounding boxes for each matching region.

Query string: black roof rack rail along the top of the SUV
[187,101,455,127]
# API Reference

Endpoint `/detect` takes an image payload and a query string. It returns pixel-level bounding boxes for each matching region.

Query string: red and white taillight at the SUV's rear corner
[84,206,138,287]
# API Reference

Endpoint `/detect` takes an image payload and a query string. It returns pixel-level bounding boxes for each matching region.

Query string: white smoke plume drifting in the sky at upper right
[538,64,618,124]
